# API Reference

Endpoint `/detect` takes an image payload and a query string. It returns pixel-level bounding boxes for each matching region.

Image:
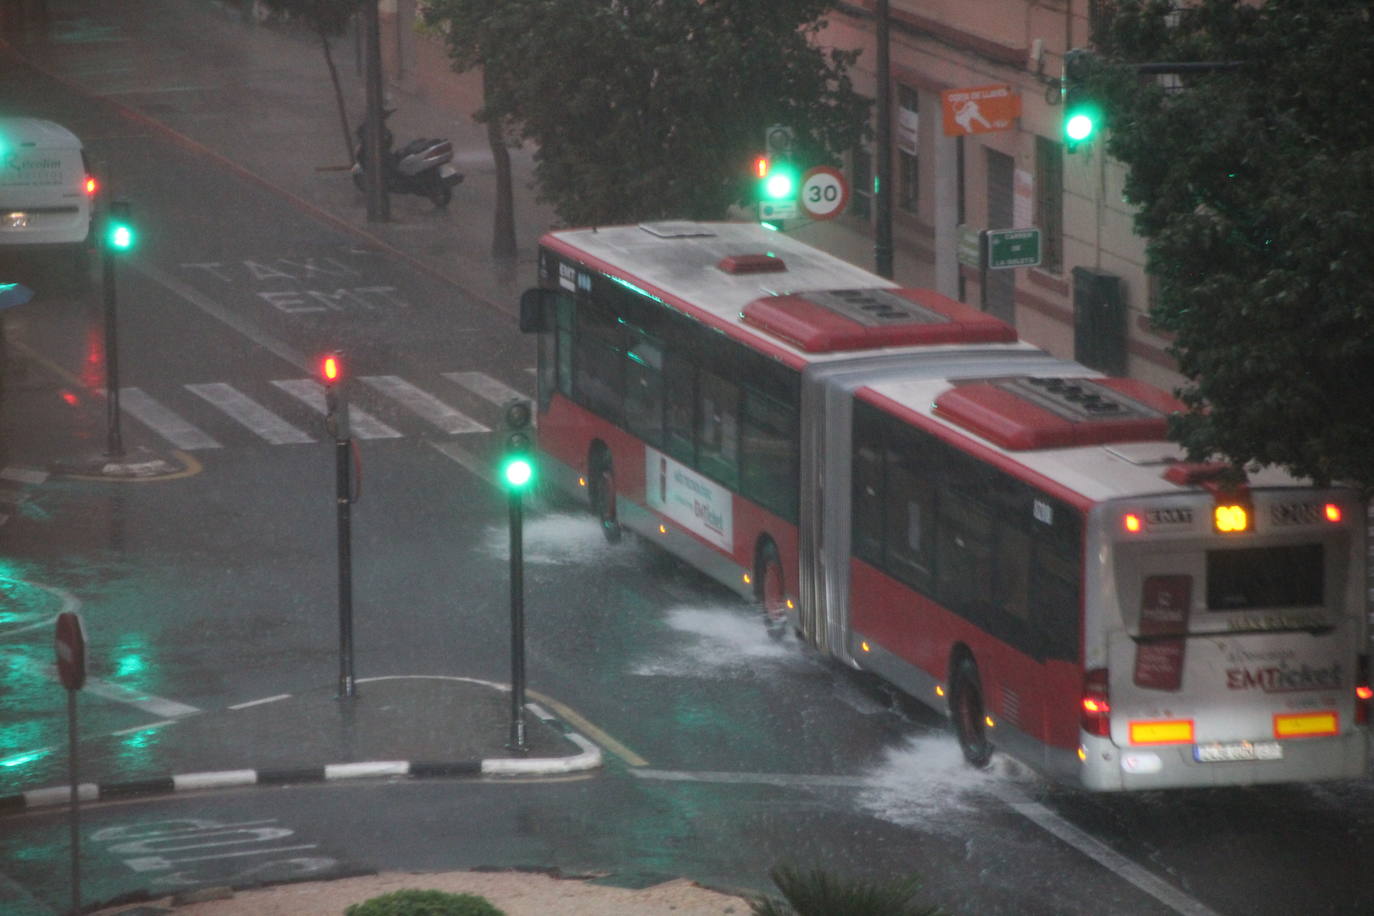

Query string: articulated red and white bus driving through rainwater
[521,222,1370,790]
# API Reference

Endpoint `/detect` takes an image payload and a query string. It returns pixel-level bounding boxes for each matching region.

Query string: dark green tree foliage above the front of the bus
[426,0,867,224]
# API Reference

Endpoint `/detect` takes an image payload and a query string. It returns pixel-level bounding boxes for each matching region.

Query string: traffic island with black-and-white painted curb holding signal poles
[0,677,602,814]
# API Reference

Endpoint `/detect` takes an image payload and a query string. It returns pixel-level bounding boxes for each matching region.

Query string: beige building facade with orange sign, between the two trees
[822,0,1182,387]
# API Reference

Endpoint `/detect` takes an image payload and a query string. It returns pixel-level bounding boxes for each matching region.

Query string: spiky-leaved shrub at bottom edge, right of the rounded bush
[750,865,940,916]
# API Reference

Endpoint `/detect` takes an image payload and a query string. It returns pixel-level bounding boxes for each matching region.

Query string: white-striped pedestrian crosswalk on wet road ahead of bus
[120,371,529,452]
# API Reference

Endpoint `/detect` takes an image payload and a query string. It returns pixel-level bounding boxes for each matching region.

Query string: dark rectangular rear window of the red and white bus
[1206,544,1325,611]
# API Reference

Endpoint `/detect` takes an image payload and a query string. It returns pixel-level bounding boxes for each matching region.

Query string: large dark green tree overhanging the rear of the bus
[1091,0,1374,489]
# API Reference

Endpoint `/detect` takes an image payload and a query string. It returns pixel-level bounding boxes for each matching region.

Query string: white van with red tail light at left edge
[0,117,96,247]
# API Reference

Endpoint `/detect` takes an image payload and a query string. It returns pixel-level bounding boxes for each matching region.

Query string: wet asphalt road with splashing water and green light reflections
[0,4,1374,913]
